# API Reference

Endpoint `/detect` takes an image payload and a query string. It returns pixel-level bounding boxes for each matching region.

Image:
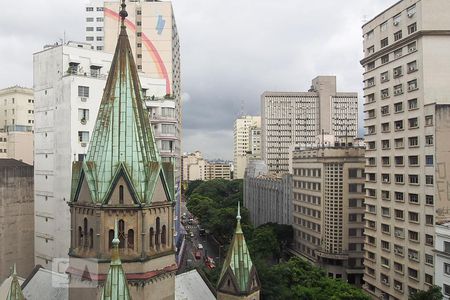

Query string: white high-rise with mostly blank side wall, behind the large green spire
[34,42,168,268]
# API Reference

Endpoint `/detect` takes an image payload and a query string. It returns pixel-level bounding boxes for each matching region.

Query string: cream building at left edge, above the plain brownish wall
[0,85,34,132]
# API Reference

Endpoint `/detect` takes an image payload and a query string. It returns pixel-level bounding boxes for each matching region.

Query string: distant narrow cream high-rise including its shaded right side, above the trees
[233,116,261,179]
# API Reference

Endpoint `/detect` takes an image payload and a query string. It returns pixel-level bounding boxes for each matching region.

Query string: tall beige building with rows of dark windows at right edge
[361,0,450,299]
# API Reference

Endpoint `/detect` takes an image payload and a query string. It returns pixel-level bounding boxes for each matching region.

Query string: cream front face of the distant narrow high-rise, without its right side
[233,116,261,179]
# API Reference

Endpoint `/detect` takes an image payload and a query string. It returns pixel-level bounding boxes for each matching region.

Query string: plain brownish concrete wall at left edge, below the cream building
[0,159,34,282]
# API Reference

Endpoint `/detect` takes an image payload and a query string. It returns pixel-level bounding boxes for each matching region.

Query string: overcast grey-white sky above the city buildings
[0,0,397,159]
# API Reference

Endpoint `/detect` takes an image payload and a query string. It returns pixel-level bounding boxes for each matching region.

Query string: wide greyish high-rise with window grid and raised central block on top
[261,76,358,173]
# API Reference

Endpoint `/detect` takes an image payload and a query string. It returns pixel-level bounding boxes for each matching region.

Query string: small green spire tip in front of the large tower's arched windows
[101,220,131,300]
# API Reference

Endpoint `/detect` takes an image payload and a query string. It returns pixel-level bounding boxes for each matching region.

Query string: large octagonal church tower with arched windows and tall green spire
[67,0,177,300]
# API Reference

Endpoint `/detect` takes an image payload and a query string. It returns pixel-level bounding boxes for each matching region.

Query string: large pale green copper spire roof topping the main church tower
[76,4,173,203]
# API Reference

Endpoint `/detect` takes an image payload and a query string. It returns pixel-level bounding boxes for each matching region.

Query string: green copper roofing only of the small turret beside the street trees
[219,204,253,292]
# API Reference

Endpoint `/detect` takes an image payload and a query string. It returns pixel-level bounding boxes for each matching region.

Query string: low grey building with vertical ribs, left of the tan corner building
[244,161,293,227]
